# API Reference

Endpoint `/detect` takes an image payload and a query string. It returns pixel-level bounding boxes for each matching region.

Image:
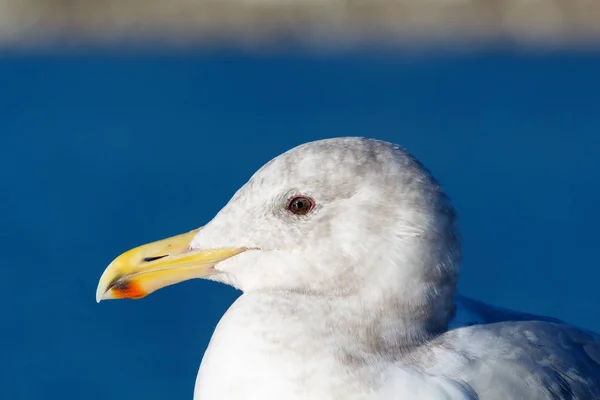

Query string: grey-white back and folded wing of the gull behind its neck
[430,296,600,400]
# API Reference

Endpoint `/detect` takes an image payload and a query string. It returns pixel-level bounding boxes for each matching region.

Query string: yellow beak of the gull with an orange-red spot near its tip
[96,229,247,302]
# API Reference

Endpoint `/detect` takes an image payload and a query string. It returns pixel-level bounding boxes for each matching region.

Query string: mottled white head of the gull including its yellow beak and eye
[96,138,460,328]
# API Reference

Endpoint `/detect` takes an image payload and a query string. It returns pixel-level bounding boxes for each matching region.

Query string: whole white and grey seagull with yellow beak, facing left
[96,137,600,400]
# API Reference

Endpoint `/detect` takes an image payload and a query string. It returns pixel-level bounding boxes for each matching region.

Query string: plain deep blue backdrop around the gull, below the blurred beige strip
[0,51,600,400]
